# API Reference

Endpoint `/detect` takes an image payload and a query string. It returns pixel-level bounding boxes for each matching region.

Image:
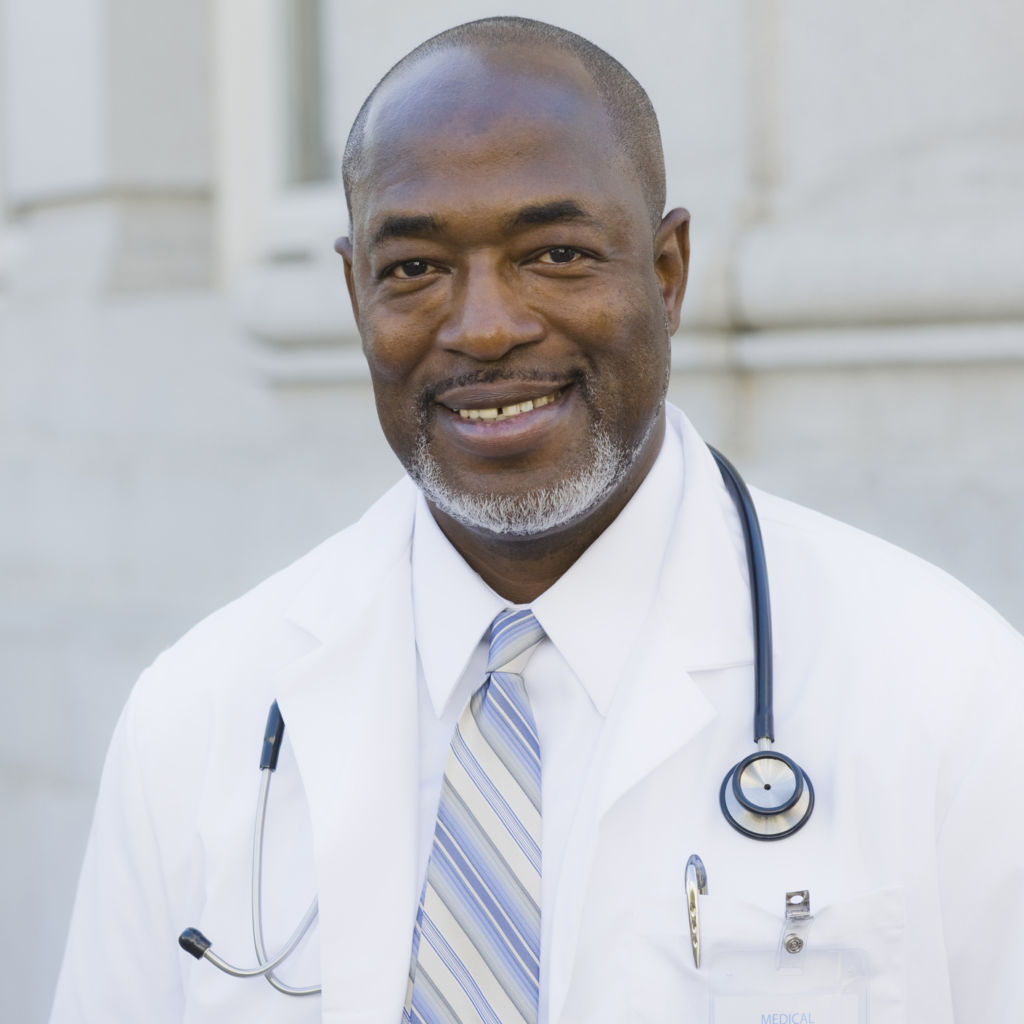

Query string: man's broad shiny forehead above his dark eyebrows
[352,46,646,233]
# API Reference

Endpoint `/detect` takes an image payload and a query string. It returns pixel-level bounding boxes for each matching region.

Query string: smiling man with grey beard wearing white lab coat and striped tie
[53,18,1024,1024]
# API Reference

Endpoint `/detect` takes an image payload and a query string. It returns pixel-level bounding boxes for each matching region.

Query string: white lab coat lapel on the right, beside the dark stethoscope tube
[549,414,754,1022]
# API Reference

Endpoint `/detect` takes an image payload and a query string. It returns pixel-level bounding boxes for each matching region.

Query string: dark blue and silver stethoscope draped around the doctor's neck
[178,449,814,995]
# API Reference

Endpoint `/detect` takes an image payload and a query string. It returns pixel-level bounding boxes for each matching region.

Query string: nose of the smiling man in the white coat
[437,257,544,362]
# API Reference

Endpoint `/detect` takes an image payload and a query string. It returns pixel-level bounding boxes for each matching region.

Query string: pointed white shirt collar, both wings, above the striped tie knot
[412,419,683,718]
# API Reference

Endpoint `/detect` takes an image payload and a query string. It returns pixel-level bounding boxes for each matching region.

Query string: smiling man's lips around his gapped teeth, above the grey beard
[436,381,579,459]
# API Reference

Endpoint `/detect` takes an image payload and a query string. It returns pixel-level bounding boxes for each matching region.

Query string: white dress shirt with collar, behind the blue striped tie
[411,419,684,1024]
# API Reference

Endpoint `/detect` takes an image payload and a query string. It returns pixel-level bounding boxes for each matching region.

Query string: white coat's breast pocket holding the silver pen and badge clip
[627,888,908,1024]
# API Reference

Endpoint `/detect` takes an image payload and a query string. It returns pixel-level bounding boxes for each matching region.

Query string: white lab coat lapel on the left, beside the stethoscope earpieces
[279,485,419,1021]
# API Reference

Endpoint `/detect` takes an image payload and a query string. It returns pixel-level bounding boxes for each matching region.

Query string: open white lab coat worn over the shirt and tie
[52,411,1024,1024]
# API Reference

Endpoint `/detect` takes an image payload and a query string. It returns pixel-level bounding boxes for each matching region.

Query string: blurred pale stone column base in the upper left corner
[0,0,211,297]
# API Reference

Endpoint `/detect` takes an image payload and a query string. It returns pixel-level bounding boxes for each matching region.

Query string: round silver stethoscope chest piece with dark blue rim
[719,750,814,840]
